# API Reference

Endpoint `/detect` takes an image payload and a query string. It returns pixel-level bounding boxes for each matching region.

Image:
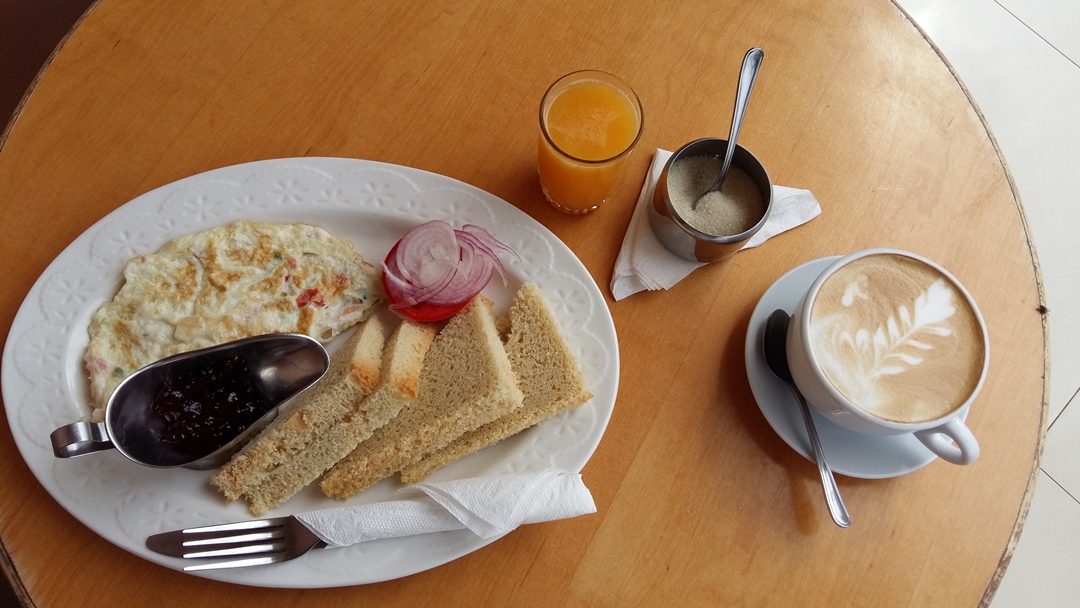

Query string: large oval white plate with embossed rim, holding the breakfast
[2,158,619,587]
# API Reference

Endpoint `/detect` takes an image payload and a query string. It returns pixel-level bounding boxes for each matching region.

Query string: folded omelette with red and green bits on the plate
[83,221,383,421]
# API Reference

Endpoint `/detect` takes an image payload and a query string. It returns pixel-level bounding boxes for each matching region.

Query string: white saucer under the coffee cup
[746,257,937,479]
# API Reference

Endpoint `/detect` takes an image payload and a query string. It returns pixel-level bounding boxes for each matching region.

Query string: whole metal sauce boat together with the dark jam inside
[50,334,329,469]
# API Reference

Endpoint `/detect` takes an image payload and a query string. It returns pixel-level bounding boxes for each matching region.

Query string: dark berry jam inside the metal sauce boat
[152,353,272,458]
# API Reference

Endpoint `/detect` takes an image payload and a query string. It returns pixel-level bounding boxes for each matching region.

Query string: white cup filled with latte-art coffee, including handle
[787,248,990,464]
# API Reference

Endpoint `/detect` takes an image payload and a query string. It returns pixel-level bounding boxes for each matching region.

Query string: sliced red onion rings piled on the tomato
[382,220,519,308]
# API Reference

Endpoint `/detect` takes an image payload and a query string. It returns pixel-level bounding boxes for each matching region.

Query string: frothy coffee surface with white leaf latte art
[809,253,987,423]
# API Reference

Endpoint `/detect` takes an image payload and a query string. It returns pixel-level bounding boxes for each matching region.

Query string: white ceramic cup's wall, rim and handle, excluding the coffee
[787,248,990,464]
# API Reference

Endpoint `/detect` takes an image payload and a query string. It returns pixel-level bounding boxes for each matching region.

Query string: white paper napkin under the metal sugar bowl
[611,148,821,300]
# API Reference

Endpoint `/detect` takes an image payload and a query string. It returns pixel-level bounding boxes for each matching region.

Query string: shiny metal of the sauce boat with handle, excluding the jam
[49,334,329,469]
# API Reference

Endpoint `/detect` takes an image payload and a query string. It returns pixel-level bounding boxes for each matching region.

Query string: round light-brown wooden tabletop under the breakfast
[0,0,1047,608]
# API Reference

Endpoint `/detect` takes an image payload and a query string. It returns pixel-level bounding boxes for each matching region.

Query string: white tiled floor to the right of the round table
[895,0,1080,608]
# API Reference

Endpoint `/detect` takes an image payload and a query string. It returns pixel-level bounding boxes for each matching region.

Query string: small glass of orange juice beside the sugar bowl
[537,70,645,214]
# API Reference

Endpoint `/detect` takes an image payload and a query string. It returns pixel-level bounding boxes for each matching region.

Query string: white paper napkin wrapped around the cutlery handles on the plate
[295,469,596,546]
